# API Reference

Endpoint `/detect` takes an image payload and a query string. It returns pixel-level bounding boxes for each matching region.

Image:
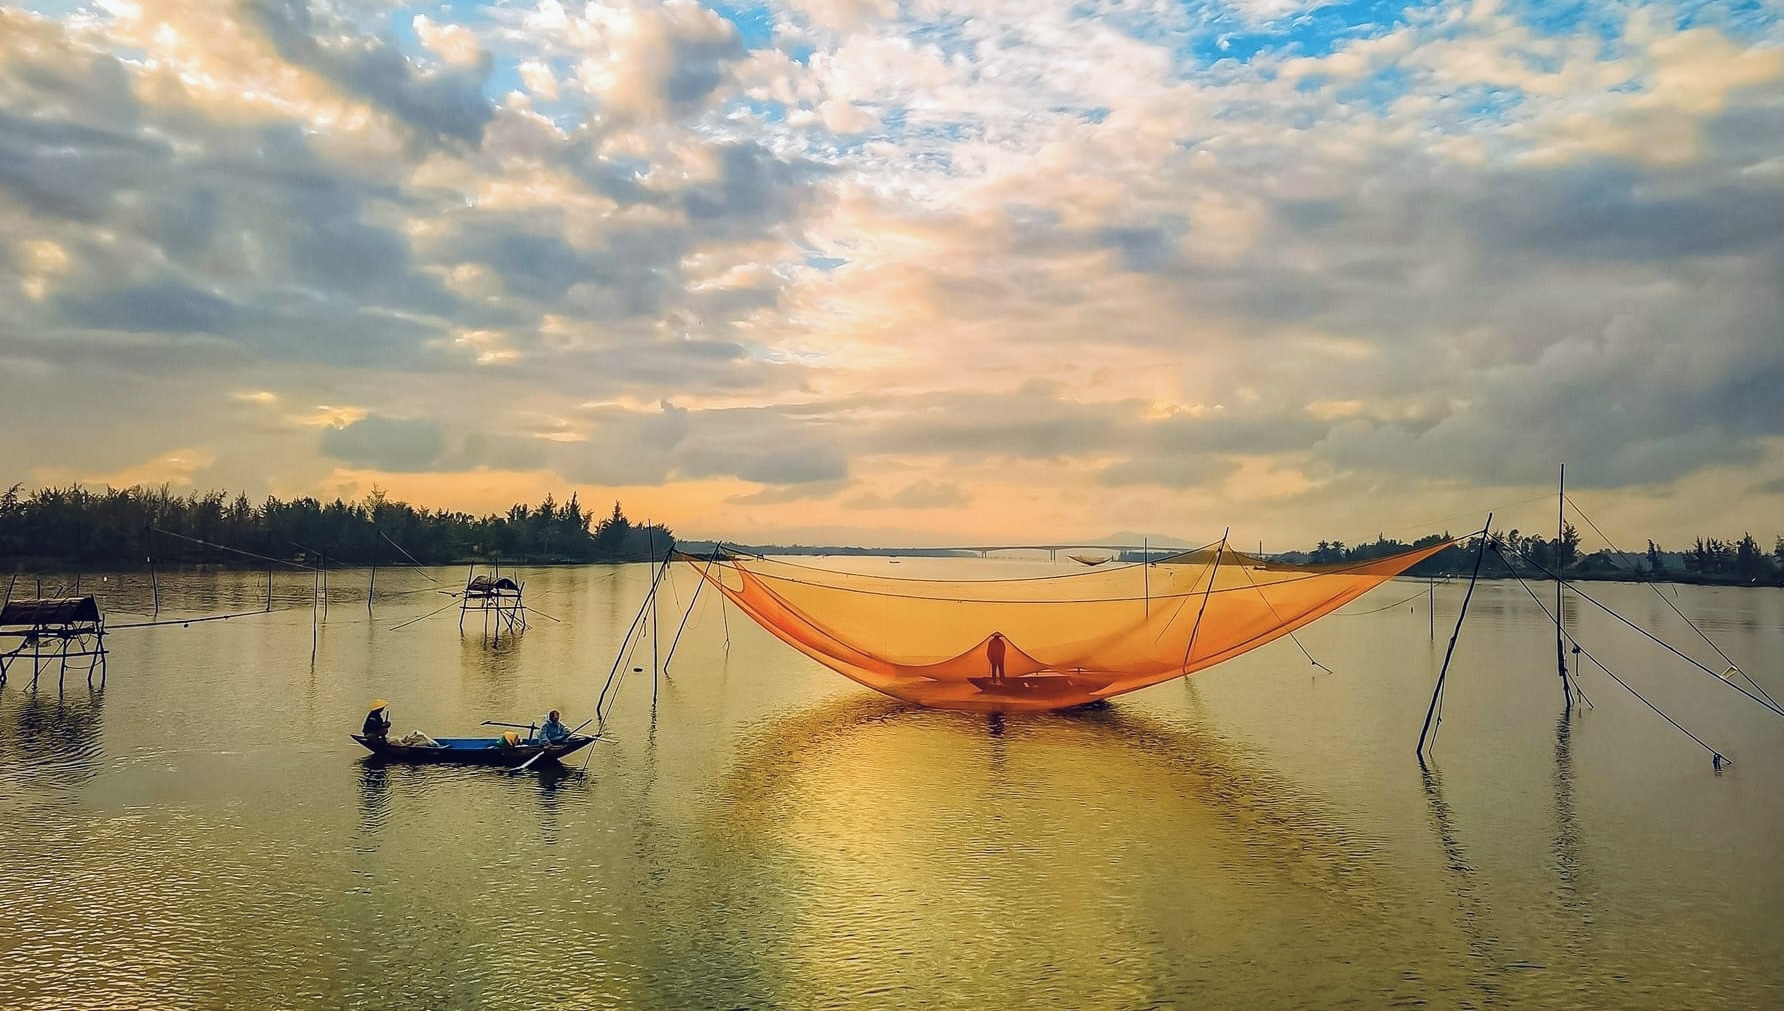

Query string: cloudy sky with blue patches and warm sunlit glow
[0,0,1784,549]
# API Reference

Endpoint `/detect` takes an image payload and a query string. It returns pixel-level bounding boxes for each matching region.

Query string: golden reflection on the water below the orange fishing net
[662,697,1420,1006]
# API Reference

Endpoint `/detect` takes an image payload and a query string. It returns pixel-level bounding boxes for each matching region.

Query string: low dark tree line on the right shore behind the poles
[1283,522,1784,587]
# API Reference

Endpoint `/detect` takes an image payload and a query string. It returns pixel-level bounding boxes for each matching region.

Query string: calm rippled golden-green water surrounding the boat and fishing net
[0,560,1784,1009]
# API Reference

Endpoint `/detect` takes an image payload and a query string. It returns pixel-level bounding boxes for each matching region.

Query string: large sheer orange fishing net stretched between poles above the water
[683,542,1450,711]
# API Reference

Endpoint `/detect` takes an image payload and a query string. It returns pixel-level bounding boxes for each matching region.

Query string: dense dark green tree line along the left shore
[0,485,674,569]
